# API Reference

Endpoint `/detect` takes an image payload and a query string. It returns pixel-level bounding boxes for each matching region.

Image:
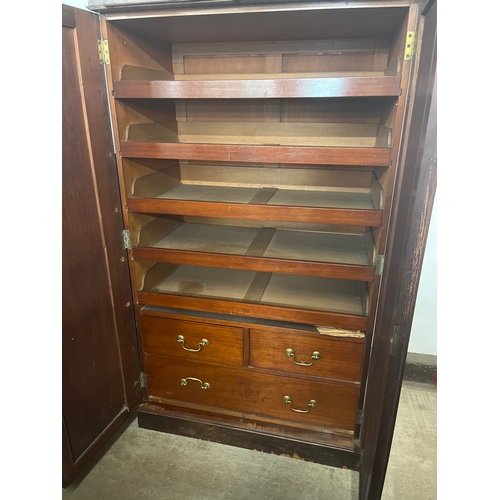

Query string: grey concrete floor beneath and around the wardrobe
[62,382,437,500]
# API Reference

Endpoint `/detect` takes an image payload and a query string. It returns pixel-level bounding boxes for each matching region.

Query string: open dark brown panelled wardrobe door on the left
[62,5,140,486]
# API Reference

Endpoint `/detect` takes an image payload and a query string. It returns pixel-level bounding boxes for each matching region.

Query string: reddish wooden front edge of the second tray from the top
[120,141,391,167]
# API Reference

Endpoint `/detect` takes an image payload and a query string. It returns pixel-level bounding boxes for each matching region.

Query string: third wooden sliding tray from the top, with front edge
[127,162,384,227]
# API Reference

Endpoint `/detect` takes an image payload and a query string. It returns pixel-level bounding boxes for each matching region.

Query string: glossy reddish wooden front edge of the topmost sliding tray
[113,76,401,99]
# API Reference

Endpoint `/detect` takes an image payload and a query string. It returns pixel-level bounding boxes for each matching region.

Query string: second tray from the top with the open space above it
[119,96,395,167]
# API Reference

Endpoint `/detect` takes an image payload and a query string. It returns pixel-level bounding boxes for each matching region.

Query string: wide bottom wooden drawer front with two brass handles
[145,356,359,431]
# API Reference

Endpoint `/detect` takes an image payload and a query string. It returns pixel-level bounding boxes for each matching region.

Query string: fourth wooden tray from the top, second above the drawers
[133,220,375,281]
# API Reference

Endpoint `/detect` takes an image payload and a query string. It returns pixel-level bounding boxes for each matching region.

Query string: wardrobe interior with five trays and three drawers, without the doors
[106,4,408,447]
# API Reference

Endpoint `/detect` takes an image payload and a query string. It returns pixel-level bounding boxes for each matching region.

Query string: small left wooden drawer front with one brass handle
[141,316,243,366]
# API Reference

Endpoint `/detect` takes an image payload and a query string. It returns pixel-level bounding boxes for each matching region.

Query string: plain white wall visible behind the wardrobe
[64,0,437,355]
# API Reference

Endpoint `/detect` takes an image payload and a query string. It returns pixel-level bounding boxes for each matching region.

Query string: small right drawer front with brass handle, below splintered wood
[250,329,364,382]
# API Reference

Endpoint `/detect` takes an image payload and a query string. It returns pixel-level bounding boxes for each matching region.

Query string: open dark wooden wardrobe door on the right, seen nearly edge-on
[359,0,437,500]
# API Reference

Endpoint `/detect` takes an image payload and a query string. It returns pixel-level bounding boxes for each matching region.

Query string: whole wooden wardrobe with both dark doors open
[63,0,436,500]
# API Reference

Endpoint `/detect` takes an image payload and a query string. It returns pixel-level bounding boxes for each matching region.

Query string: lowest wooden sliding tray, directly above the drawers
[138,263,368,330]
